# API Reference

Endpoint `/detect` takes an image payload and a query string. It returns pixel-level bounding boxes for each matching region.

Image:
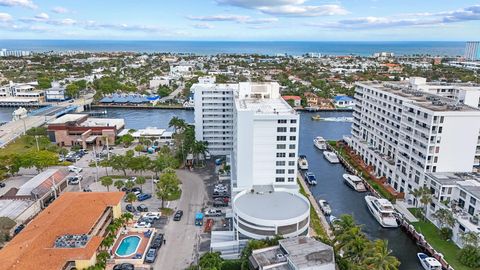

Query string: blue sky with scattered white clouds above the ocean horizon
[0,0,480,41]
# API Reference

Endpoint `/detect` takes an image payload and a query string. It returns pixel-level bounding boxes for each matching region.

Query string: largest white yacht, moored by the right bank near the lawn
[365,196,398,228]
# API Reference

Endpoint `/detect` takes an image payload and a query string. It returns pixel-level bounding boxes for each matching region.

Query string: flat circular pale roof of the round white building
[234,191,310,220]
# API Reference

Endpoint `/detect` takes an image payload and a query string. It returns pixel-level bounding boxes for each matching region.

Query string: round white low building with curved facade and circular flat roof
[232,190,310,239]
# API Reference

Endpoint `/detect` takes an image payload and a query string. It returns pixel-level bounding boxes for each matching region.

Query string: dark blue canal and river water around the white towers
[0,108,422,270]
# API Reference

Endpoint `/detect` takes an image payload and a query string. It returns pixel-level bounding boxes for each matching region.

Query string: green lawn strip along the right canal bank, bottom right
[409,209,475,270]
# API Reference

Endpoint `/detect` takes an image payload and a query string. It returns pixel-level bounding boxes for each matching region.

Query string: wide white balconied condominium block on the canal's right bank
[351,78,480,206]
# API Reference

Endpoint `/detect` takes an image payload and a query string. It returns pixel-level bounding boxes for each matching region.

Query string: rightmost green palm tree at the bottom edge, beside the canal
[363,240,400,270]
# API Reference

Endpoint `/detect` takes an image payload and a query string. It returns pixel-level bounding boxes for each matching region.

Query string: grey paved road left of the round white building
[154,170,207,270]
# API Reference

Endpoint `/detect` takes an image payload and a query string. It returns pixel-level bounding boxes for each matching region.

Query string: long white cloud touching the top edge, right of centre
[215,0,349,17]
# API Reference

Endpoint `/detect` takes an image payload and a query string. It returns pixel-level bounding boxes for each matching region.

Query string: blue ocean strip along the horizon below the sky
[0,40,465,56]
